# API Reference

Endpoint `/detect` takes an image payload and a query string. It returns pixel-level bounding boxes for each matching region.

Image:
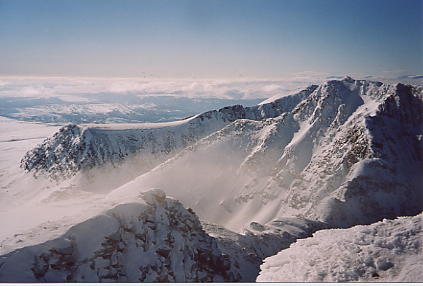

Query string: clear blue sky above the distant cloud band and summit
[0,0,423,78]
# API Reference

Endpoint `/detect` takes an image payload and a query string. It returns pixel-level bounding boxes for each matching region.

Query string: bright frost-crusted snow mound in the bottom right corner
[257,214,423,282]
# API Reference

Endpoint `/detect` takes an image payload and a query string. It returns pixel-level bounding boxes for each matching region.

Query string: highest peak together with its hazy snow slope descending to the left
[104,78,423,231]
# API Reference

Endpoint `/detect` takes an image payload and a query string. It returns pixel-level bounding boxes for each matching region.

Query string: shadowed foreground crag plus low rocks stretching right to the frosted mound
[0,189,323,282]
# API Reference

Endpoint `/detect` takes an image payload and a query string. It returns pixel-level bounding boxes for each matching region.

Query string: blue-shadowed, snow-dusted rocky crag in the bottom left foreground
[0,190,240,282]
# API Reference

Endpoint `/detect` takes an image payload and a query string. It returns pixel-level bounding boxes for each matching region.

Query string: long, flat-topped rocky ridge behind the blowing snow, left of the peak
[21,86,316,180]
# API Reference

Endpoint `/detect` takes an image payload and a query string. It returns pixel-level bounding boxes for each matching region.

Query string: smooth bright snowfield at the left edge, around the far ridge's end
[0,117,107,253]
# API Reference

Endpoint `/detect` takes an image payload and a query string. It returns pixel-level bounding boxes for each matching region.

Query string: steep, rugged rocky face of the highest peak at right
[264,79,423,227]
